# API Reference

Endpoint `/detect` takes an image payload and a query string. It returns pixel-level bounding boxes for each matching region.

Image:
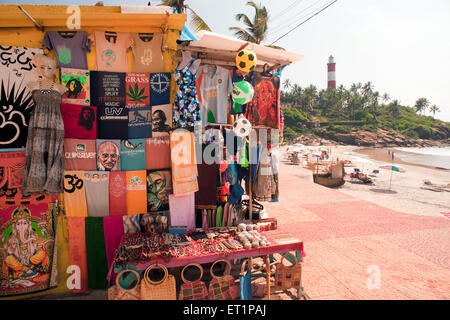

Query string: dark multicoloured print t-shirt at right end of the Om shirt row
[147,170,172,212]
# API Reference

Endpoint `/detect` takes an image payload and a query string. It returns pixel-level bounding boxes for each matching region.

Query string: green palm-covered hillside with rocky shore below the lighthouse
[281,80,450,146]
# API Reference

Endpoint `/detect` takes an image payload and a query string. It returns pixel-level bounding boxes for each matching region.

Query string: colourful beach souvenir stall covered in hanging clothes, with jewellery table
[0,5,303,299]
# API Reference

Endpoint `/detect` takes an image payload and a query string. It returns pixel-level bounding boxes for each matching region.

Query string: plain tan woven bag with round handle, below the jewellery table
[141,263,177,300]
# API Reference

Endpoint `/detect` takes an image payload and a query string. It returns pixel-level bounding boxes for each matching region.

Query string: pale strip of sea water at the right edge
[396,147,450,170]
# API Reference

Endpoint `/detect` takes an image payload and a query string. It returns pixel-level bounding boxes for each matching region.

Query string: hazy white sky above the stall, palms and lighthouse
[0,0,450,121]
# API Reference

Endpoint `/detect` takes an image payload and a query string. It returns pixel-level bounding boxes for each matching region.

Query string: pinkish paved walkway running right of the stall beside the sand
[266,164,450,300]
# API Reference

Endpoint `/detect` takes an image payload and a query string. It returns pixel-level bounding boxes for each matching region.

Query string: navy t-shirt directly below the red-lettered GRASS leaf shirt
[128,107,152,138]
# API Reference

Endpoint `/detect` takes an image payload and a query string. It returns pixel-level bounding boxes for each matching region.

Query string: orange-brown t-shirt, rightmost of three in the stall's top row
[131,33,164,73]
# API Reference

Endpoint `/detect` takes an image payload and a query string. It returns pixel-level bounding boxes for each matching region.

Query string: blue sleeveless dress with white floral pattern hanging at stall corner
[173,59,200,128]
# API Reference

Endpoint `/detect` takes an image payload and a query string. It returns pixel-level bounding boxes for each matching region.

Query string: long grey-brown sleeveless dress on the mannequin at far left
[22,82,64,195]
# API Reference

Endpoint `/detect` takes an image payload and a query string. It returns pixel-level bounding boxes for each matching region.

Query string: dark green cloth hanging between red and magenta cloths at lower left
[85,217,108,289]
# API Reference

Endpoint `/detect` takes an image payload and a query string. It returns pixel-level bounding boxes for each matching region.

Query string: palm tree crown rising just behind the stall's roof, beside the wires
[228,1,269,44]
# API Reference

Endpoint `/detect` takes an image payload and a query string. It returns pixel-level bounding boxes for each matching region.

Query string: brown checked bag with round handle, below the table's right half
[208,260,240,300]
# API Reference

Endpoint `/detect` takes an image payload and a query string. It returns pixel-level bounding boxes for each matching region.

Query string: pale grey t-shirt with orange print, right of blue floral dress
[196,66,233,126]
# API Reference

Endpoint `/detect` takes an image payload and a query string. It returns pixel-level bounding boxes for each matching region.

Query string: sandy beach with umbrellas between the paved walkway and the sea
[284,146,450,217]
